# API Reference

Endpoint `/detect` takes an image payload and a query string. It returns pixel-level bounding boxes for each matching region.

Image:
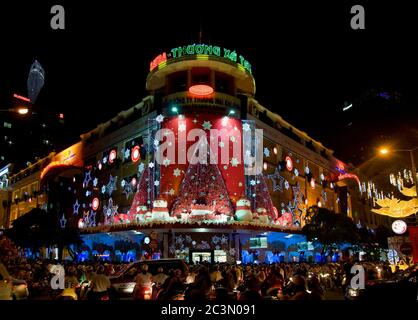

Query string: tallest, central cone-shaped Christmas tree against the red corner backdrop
[172,140,234,216]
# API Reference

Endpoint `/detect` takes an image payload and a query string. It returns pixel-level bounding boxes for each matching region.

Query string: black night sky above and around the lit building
[0,1,418,169]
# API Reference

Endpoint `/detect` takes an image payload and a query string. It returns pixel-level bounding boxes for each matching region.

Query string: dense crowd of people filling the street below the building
[1,235,402,300]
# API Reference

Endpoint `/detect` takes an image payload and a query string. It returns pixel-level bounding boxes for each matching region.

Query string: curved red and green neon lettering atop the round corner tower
[150,43,252,74]
